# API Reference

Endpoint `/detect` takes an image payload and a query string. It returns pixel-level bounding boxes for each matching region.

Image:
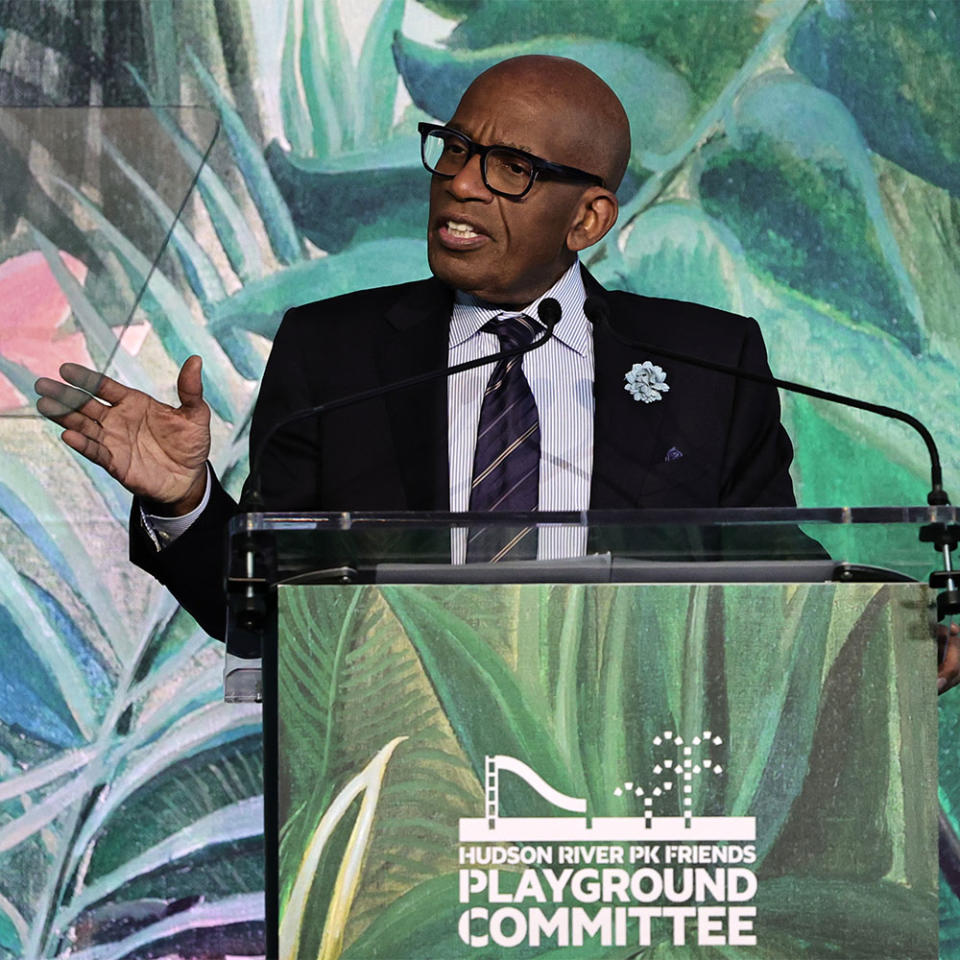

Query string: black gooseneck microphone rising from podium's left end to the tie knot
[240,297,561,513]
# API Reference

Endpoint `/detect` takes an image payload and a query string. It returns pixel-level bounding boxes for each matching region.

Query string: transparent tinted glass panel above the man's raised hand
[0,107,218,417]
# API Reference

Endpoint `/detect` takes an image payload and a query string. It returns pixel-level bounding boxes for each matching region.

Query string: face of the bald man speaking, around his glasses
[427,76,585,306]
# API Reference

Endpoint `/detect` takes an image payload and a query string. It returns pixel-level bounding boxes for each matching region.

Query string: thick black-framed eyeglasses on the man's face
[417,123,603,200]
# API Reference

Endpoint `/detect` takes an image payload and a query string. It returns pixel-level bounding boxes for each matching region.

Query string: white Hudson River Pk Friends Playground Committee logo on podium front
[458,730,757,948]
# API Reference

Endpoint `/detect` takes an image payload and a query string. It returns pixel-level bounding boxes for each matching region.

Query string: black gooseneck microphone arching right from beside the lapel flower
[583,296,950,506]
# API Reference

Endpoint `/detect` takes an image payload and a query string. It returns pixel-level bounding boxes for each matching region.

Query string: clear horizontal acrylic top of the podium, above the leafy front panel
[231,506,956,582]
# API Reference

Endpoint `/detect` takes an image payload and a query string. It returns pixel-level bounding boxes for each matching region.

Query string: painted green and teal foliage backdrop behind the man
[0,0,960,960]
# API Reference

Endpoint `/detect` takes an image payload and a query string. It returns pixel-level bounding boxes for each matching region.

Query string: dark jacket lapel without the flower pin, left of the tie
[374,278,453,510]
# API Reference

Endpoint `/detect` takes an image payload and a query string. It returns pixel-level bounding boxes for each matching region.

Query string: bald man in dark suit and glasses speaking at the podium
[37,56,794,637]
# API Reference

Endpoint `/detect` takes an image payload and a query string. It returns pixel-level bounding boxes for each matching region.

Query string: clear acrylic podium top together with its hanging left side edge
[225,506,958,700]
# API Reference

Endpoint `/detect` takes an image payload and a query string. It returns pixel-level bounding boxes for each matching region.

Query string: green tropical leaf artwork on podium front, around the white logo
[278,585,936,960]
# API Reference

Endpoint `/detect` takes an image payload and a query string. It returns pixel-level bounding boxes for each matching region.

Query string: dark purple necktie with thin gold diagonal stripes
[467,314,541,563]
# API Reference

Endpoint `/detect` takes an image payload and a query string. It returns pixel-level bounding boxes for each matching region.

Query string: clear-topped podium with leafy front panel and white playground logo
[226,507,944,960]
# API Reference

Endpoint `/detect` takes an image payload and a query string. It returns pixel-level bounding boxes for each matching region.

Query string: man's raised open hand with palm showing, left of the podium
[35,356,210,515]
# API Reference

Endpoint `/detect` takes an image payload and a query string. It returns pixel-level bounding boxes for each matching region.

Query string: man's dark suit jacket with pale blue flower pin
[131,272,795,637]
